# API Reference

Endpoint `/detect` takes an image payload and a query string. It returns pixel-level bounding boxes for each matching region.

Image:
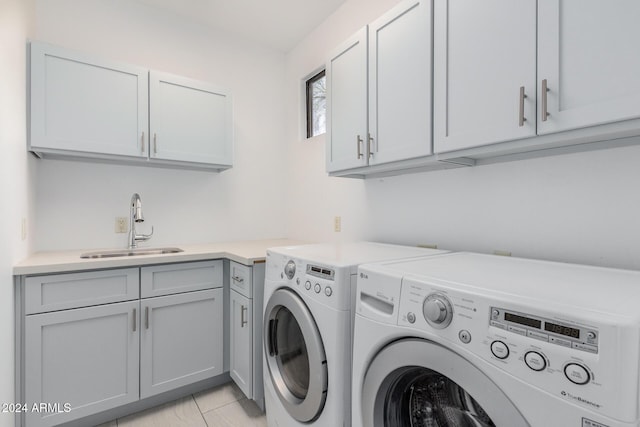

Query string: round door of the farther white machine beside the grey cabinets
[263,289,327,422]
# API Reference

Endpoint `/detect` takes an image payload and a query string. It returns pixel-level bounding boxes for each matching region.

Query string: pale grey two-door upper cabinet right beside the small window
[326,0,432,175]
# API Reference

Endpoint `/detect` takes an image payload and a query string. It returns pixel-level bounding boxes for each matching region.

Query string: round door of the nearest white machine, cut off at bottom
[362,339,529,427]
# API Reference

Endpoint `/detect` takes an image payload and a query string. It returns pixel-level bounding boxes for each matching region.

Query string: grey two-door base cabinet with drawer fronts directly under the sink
[16,260,224,427]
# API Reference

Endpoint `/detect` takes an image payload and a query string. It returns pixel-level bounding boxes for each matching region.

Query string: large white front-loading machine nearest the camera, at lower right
[353,253,640,427]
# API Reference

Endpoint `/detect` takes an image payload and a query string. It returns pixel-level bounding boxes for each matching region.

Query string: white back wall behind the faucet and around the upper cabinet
[35,0,286,250]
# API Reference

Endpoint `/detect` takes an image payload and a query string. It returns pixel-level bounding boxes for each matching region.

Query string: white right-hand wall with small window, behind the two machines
[286,0,640,269]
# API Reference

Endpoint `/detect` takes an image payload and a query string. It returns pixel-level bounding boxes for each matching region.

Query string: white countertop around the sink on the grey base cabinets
[13,239,305,276]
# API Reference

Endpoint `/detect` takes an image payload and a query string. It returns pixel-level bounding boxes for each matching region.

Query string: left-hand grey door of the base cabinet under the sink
[24,301,140,427]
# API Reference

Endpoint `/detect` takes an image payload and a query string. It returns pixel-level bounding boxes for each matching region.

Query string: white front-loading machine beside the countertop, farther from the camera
[263,242,445,427]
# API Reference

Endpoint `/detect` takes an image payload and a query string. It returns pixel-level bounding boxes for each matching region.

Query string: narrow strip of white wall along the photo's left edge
[0,0,34,427]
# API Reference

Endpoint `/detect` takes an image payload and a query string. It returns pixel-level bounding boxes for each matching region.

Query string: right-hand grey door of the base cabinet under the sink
[140,289,223,398]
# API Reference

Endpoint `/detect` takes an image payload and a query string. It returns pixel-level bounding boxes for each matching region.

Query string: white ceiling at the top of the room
[138,0,345,52]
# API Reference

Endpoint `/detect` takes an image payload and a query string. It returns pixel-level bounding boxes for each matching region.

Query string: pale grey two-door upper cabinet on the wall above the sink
[29,42,233,170]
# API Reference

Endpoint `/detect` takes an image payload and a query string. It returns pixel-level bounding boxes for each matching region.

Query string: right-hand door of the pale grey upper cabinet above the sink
[149,71,233,167]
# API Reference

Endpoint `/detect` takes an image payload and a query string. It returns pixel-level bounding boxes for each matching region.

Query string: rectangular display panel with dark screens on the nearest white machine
[489,307,598,354]
